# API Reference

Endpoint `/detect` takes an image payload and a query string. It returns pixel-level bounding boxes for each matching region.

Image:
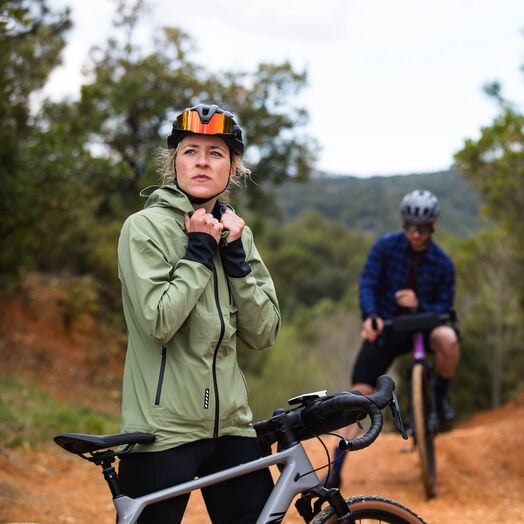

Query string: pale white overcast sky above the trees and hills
[46,0,524,176]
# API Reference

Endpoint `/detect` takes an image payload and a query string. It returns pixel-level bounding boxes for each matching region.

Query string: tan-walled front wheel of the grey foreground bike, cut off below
[310,495,425,524]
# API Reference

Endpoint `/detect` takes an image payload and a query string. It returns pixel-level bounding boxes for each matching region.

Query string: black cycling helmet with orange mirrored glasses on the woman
[167,104,244,155]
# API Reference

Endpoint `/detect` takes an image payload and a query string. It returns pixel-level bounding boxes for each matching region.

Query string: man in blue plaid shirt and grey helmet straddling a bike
[326,189,460,487]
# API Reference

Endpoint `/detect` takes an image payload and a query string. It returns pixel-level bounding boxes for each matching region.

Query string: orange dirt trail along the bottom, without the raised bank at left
[0,400,524,524]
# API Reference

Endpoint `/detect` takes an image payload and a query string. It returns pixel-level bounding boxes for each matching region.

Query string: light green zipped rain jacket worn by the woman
[118,186,280,451]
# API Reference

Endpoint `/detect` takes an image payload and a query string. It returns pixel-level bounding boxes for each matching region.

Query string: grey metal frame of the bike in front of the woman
[113,443,320,524]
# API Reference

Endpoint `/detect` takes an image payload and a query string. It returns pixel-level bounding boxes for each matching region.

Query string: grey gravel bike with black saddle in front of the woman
[54,375,424,524]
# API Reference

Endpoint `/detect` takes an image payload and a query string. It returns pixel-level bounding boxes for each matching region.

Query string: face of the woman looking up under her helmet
[175,134,231,203]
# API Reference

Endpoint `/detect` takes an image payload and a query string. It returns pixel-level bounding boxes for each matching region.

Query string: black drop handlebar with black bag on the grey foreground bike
[254,375,396,450]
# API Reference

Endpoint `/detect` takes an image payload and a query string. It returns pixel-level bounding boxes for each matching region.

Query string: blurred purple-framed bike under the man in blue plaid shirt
[384,312,458,498]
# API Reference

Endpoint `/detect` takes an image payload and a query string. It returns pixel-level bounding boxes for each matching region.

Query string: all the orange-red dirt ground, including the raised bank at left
[0,275,524,524]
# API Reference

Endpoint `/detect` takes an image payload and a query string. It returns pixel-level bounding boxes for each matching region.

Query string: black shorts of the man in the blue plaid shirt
[352,330,429,388]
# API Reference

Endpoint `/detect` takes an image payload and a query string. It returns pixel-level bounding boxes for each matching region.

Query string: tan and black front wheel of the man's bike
[411,363,437,498]
